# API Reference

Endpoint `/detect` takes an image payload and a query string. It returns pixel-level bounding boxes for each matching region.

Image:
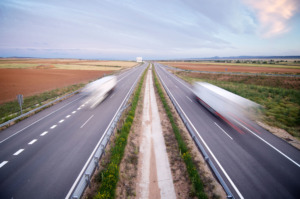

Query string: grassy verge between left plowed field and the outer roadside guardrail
[0,83,85,123]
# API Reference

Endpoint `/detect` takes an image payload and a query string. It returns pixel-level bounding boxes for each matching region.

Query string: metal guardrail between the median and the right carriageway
[157,64,234,198]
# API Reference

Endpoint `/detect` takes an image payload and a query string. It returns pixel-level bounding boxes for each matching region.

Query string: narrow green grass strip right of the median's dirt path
[152,66,207,199]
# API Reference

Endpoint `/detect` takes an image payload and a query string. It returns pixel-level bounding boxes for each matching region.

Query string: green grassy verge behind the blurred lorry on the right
[179,73,300,139]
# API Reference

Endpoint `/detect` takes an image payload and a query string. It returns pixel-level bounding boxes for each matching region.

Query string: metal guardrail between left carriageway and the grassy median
[66,65,142,199]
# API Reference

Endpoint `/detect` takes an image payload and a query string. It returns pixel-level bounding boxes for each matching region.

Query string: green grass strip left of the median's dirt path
[94,65,148,199]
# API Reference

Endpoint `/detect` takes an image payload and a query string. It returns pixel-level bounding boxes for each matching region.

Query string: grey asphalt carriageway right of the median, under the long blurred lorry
[155,63,300,198]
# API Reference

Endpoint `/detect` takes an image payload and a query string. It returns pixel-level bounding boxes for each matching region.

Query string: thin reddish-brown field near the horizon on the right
[162,62,300,74]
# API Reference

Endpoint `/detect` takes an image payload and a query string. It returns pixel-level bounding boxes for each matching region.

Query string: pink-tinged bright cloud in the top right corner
[244,0,299,38]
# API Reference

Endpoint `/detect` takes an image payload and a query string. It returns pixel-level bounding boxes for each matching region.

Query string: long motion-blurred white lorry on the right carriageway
[193,82,260,120]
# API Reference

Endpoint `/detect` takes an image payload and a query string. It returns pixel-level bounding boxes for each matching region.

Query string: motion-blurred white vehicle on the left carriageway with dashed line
[82,75,117,108]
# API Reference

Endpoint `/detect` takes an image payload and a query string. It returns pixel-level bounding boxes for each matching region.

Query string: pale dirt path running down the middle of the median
[137,66,176,199]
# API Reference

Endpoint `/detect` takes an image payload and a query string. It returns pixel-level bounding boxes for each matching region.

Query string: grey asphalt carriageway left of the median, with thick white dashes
[0,63,147,199]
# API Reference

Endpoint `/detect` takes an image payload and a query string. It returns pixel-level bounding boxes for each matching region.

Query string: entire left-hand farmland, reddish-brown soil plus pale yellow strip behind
[0,58,137,104]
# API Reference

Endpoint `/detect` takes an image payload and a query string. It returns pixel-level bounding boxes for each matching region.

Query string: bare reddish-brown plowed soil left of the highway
[0,69,111,104]
